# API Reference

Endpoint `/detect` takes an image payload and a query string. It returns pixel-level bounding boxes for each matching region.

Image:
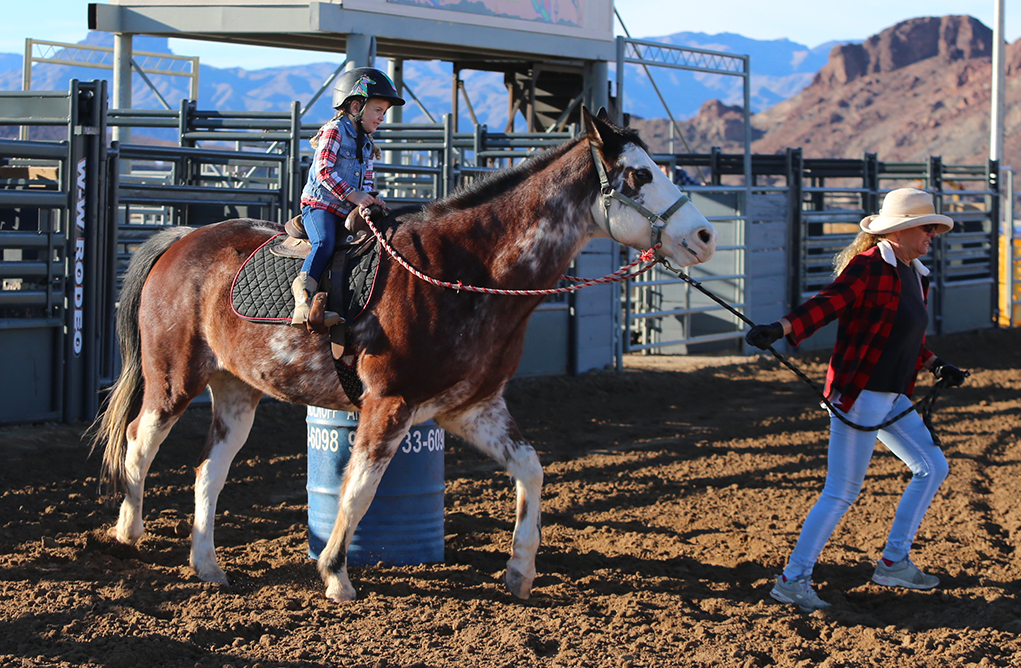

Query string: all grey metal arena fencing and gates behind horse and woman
[0,82,1004,422]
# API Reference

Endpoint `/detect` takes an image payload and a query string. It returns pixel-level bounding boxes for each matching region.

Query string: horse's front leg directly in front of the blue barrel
[319,397,412,603]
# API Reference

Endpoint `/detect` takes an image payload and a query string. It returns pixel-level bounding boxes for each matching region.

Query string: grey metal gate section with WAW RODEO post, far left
[0,81,115,422]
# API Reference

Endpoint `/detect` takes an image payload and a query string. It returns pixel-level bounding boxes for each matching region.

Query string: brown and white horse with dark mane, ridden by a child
[94,109,716,603]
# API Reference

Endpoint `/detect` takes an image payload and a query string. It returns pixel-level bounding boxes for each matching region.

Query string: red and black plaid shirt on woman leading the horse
[784,246,932,412]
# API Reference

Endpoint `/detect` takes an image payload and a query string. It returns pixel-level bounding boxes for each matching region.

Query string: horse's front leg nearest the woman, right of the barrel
[436,396,542,599]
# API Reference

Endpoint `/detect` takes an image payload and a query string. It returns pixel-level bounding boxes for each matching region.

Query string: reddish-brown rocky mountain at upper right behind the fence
[633,16,1021,173]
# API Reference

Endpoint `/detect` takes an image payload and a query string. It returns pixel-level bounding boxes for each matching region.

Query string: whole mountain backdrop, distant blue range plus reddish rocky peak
[0,15,1021,171]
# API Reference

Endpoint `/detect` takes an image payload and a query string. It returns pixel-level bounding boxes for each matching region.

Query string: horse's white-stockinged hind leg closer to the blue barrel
[190,373,262,584]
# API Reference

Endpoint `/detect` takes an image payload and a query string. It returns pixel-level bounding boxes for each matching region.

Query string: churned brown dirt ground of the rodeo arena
[0,330,1021,668]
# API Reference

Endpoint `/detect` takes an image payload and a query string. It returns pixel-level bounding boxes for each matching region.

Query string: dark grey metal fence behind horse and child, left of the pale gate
[0,81,588,423]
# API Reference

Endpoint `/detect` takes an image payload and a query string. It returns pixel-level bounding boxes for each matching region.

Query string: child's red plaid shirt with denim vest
[301,116,375,217]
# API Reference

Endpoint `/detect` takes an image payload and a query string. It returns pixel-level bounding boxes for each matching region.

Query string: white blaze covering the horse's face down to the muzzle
[596,144,716,267]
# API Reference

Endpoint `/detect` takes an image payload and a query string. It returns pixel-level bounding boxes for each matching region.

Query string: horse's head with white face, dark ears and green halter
[582,109,716,267]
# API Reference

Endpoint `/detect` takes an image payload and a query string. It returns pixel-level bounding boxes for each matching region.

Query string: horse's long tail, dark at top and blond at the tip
[92,227,194,494]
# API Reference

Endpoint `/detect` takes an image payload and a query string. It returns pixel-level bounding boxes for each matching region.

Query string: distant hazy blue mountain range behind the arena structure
[0,31,841,129]
